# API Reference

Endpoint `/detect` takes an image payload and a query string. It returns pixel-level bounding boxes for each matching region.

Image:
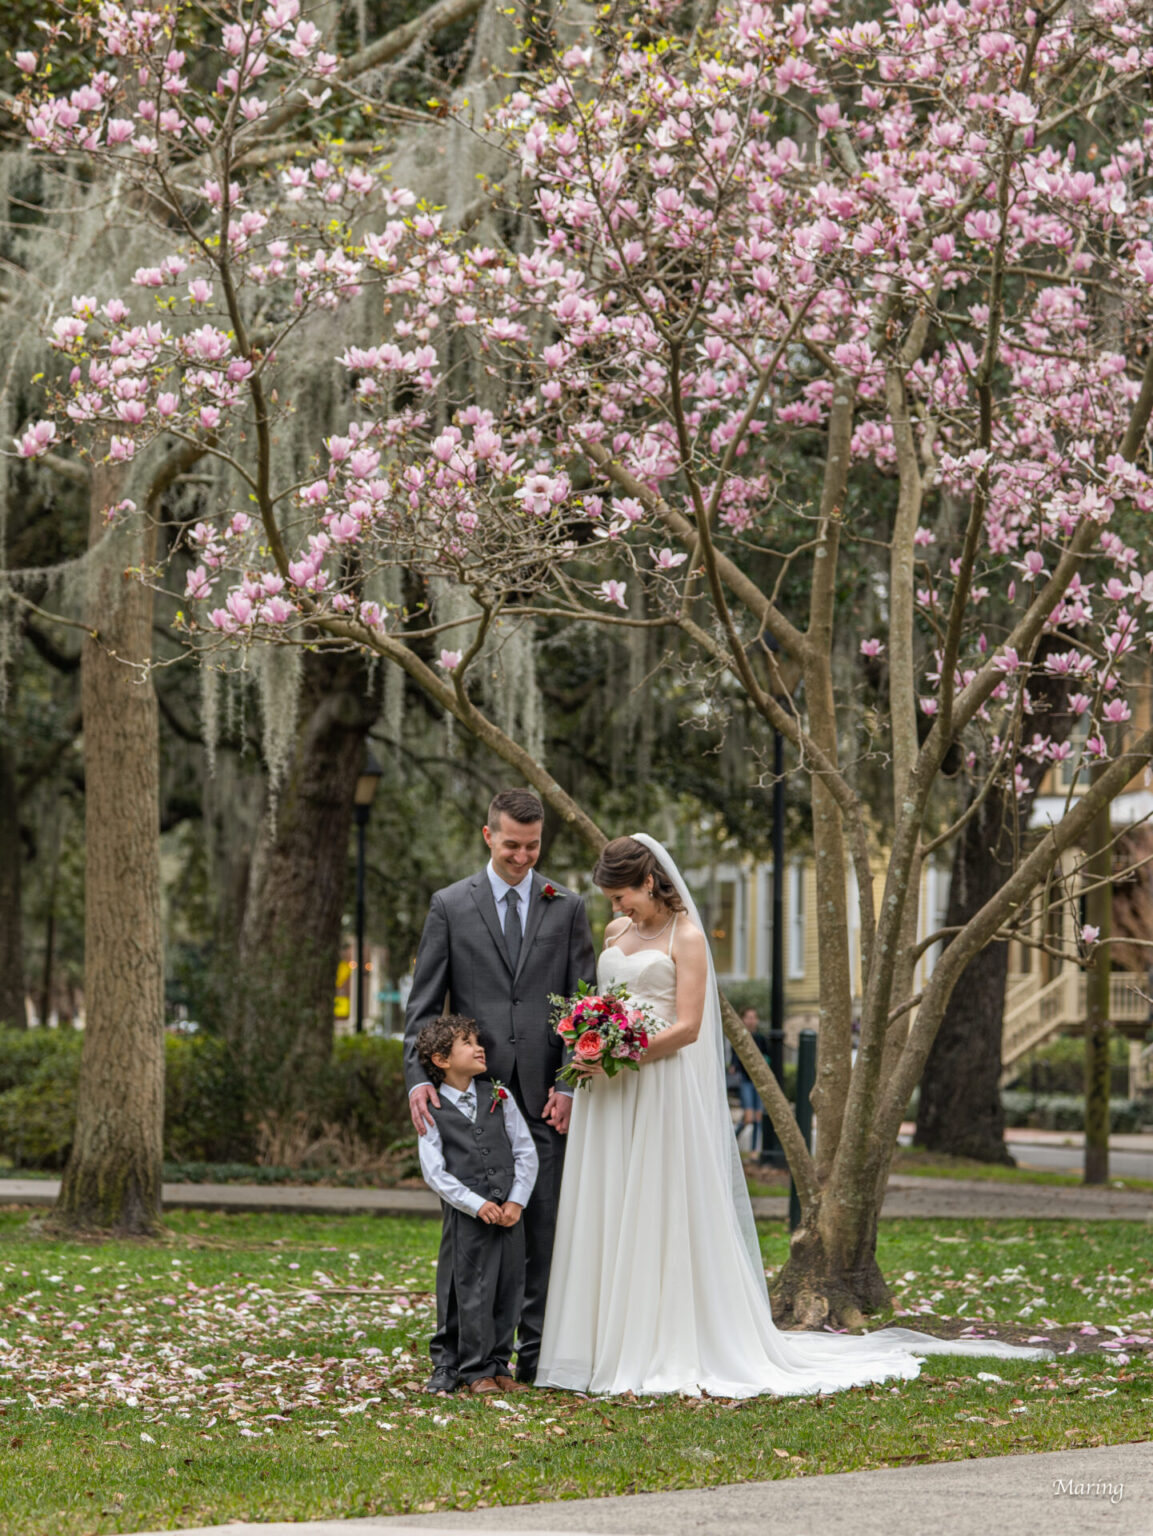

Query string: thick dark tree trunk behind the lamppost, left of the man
[233,651,379,1114]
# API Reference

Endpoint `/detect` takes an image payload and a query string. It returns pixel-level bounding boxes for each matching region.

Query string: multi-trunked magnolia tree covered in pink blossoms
[20,0,1153,1324]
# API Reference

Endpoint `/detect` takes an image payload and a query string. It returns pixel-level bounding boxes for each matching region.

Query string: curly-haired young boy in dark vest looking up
[416,1014,537,1396]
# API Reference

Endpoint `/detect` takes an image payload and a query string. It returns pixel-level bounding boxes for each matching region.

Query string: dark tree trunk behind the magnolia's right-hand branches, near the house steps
[913,790,1013,1164]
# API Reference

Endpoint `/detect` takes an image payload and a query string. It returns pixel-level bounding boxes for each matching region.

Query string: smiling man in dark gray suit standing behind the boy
[404,790,596,1392]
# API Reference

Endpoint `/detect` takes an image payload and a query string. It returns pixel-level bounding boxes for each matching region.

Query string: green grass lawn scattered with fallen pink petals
[0,1212,1153,1536]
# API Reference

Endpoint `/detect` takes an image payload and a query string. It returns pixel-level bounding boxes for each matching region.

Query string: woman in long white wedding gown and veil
[536,834,1049,1398]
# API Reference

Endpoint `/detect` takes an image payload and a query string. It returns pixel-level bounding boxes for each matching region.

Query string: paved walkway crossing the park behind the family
[0,1174,1153,1223]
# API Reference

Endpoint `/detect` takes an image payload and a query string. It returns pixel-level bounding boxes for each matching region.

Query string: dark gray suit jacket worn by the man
[404,869,597,1120]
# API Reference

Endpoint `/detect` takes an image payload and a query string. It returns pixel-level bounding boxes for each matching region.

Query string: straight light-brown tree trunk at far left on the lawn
[52,470,164,1233]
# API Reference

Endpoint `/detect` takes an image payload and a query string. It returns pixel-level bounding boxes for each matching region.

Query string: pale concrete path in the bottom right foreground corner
[122,1442,1153,1536]
